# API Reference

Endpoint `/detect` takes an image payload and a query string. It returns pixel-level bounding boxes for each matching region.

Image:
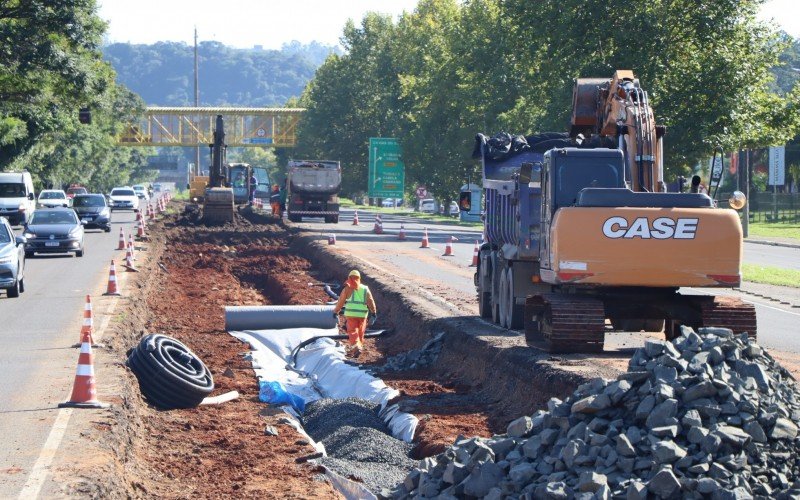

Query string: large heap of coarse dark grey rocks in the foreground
[393,328,800,499]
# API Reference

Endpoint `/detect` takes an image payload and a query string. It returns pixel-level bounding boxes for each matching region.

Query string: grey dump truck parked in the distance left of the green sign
[286,160,342,224]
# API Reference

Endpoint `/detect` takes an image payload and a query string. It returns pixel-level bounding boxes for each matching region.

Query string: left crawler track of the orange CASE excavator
[540,294,605,352]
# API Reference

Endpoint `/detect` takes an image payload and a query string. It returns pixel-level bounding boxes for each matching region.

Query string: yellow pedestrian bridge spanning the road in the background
[118,106,305,148]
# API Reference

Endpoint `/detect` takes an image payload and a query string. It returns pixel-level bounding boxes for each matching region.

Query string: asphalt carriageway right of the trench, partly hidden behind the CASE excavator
[302,210,800,353]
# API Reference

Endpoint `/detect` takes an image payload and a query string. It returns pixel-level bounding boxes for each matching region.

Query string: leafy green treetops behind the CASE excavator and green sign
[300,0,800,198]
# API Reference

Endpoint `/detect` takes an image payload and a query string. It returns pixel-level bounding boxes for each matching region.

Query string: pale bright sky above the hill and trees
[98,0,800,49]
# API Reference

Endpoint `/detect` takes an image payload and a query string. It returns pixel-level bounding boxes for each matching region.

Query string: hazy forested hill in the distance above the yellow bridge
[103,42,334,107]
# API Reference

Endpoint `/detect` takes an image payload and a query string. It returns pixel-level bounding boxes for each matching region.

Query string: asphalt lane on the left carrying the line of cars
[0,208,135,498]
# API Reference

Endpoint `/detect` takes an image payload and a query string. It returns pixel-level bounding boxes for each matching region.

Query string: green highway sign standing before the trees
[367,137,406,198]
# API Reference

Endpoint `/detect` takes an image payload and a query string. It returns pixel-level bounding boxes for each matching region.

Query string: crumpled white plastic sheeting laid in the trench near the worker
[230,328,419,442]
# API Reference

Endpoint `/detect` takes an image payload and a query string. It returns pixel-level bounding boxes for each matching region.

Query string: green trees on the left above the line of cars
[0,0,151,189]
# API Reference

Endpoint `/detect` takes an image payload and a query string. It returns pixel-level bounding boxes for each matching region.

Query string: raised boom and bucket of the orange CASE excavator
[570,70,666,192]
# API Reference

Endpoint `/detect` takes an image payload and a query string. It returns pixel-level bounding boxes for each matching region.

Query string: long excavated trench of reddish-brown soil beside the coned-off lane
[112,205,600,498]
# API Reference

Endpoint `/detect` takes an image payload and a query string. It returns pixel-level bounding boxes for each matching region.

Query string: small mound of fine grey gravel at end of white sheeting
[303,398,418,494]
